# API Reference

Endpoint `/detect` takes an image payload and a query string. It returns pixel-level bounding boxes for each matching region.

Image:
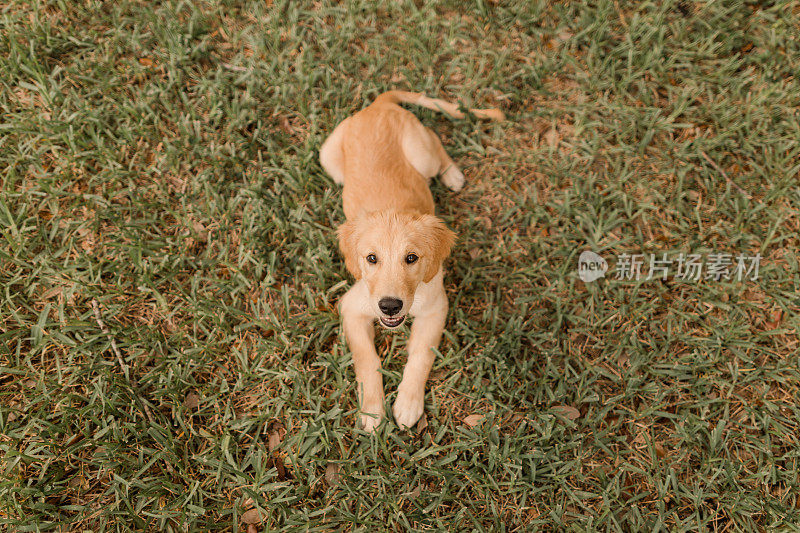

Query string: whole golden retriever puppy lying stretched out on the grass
[319,91,503,431]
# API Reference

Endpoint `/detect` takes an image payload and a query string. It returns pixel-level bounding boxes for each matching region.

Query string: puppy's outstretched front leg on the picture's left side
[342,308,383,431]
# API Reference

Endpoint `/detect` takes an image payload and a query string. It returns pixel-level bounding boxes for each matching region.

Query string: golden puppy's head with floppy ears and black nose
[338,212,455,328]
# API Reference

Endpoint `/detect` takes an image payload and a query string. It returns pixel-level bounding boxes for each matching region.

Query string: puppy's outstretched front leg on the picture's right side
[392,282,448,428]
